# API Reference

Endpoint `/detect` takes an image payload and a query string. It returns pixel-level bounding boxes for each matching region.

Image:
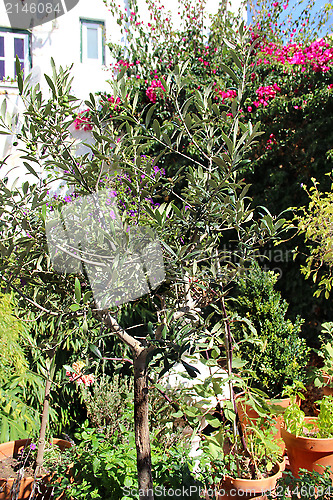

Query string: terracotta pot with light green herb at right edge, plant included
[281,396,333,478]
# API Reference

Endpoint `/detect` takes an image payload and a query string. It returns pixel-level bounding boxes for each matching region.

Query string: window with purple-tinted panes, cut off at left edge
[0,28,30,81]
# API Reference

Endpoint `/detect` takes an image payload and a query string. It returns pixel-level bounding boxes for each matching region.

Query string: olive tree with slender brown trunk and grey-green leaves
[0,24,283,499]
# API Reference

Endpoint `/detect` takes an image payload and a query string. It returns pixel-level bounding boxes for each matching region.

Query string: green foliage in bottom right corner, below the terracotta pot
[268,467,333,500]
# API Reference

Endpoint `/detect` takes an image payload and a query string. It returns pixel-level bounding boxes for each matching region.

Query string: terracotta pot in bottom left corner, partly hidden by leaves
[0,439,72,500]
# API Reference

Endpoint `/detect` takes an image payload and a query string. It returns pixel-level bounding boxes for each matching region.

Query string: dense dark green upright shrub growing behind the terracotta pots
[230,266,308,397]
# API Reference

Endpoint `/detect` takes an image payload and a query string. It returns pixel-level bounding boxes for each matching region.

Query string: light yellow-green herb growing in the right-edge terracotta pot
[284,396,333,439]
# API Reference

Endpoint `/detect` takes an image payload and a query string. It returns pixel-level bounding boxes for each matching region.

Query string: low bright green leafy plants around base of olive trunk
[55,423,199,500]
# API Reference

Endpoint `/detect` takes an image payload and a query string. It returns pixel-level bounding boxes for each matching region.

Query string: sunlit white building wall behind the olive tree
[0,0,241,184]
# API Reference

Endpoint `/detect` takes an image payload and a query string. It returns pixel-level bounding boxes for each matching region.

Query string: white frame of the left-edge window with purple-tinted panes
[0,28,30,83]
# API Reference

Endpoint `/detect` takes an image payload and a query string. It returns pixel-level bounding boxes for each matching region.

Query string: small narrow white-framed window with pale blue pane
[81,19,104,65]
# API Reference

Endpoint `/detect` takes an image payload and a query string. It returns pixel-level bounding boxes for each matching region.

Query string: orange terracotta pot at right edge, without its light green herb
[281,417,333,480]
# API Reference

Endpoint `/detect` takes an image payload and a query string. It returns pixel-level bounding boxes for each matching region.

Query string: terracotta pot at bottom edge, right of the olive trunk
[205,462,284,500]
